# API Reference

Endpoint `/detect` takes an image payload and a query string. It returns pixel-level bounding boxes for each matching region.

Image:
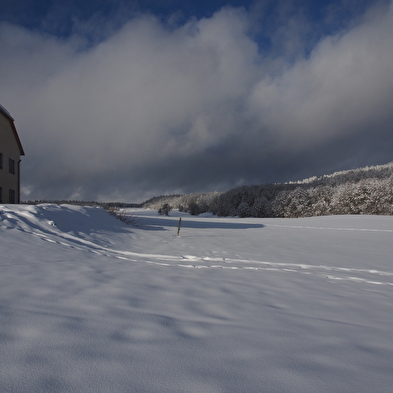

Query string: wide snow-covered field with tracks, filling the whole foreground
[0,205,393,393]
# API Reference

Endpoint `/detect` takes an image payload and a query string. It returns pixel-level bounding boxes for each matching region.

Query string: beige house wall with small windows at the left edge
[0,111,20,203]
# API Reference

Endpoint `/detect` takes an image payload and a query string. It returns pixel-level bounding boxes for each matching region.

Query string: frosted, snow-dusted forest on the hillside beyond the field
[144,162,393,218]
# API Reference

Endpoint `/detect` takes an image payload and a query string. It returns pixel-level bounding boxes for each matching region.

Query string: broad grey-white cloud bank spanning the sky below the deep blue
[0,1,393,199]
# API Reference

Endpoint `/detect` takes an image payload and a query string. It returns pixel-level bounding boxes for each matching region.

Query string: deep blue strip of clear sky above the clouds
[1,0,376,49]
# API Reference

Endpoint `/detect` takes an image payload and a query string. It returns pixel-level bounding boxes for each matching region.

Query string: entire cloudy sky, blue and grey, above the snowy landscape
[0,0,393,201]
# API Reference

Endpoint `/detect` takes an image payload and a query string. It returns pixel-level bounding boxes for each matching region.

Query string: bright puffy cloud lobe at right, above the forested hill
[250,2,393,148]
